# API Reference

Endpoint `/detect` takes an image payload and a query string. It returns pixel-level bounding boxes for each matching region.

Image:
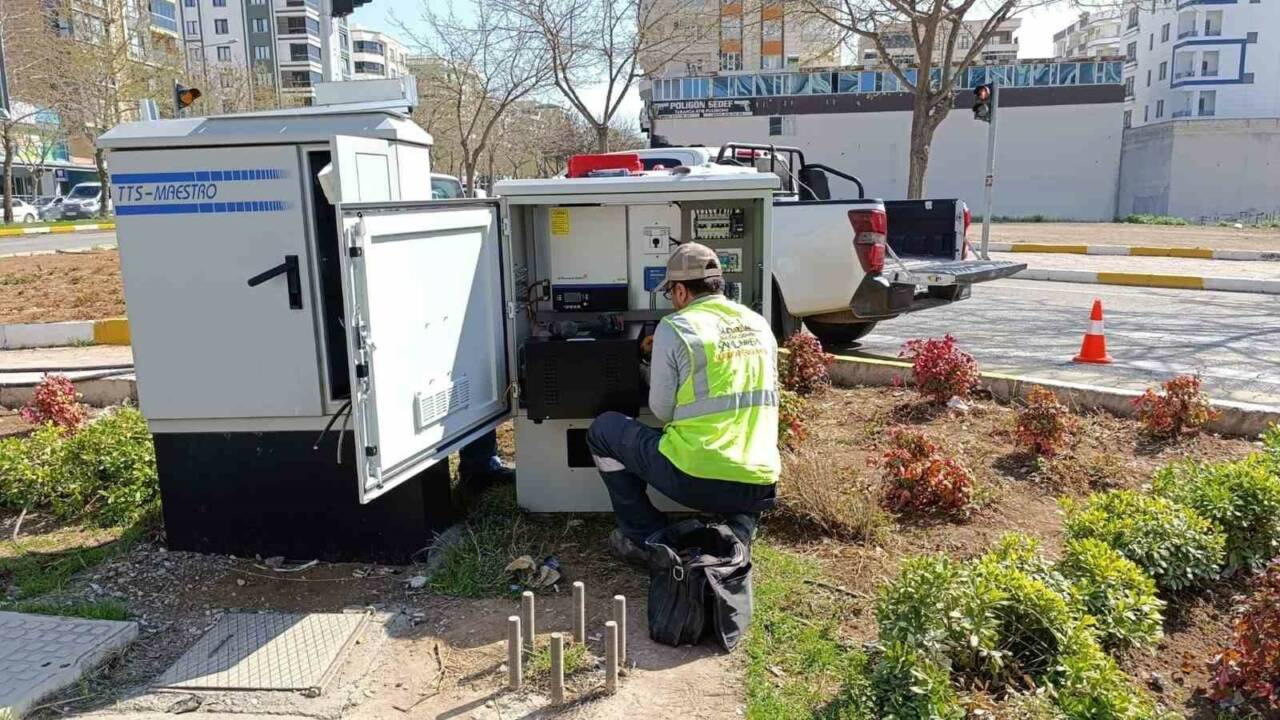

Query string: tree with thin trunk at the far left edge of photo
[0,0,67,223]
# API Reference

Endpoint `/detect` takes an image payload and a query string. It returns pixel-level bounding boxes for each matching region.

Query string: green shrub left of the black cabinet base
[0,407,159,525]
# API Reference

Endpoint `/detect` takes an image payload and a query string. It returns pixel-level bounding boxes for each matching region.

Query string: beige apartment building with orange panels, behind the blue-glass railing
[640,0,840,77]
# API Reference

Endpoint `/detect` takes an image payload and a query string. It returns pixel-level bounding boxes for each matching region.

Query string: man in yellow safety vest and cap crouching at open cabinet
[586,242,781,564]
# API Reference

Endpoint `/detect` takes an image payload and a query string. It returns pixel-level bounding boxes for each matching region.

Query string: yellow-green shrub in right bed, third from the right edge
[1057,539,1165,650]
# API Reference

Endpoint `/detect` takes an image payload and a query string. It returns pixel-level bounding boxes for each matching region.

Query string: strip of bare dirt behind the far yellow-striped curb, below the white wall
[998,223,1280,252]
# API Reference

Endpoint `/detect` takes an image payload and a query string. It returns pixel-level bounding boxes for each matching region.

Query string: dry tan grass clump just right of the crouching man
[778,447,892,542]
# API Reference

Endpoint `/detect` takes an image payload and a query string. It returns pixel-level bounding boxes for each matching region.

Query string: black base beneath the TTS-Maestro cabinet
[155,432,454,564]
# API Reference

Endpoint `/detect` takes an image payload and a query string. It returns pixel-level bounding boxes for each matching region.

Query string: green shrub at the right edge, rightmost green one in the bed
[1155,454,1280,570]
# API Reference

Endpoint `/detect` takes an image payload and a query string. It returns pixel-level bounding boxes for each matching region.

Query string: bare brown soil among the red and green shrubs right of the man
[774,388,1257,717]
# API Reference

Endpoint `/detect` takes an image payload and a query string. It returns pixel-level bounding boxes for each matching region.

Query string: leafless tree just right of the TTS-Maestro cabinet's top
[401,0,550,195]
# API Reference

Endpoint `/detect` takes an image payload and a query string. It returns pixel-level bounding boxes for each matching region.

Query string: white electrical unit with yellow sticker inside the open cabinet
[547,205,627,313]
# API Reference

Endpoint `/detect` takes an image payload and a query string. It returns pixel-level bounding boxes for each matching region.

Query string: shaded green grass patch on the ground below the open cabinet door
[428,487,547,598]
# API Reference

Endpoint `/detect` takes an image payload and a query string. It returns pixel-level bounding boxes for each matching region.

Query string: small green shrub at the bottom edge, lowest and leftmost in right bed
[872,642,965,720]
